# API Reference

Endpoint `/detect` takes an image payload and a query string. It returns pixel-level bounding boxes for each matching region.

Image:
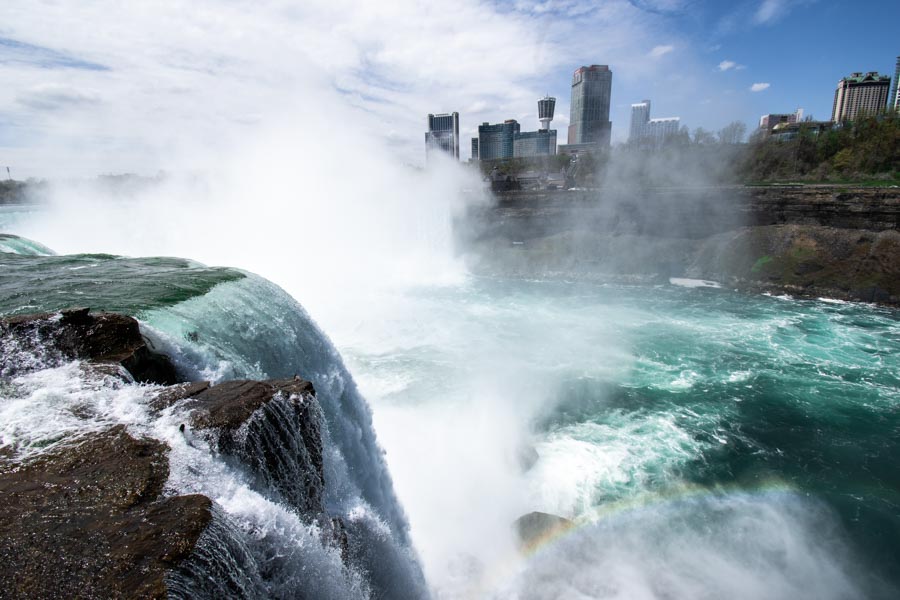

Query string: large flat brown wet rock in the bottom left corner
[0,426,211,598]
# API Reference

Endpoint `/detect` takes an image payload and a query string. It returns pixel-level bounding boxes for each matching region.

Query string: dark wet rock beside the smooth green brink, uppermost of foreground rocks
[0,308,179,385]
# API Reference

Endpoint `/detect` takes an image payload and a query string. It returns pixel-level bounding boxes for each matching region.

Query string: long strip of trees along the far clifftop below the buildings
[479,113,900,187]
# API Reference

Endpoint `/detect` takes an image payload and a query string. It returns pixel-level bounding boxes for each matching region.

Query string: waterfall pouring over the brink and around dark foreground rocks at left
[0,240,427,599]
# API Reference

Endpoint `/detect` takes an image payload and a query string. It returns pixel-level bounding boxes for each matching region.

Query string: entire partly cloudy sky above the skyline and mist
[0,0,900,179]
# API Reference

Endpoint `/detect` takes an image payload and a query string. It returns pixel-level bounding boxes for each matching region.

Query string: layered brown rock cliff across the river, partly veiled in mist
[459,186,900,305]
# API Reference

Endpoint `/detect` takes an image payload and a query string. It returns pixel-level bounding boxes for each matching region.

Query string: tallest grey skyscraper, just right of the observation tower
[568,65,612,147]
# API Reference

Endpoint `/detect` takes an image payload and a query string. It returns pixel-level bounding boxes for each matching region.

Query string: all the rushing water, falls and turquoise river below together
[0,231,900,600]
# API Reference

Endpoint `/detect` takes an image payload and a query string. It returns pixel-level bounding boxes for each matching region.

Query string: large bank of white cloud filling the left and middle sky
[0,0,744,175]
